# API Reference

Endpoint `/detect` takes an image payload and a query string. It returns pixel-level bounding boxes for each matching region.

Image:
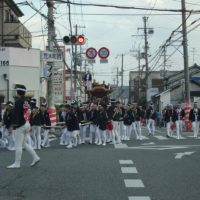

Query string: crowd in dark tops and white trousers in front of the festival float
[0,92,200,168]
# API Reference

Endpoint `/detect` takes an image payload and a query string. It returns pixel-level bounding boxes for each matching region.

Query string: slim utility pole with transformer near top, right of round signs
[143,17,149,102]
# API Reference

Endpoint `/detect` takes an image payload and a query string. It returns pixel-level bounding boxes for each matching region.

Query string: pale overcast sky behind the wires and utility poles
[15,0,200,85]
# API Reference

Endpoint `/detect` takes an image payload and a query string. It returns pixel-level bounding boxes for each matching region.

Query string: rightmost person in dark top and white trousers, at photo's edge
[189,102,200,138]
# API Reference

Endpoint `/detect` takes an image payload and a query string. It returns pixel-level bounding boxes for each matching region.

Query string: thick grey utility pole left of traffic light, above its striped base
[46,0,56,108]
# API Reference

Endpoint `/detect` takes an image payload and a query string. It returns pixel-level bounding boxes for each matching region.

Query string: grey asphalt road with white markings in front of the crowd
[0,129,200,200]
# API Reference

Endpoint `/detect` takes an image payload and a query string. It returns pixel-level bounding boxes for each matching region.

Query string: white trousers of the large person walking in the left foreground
[12,122,39,165]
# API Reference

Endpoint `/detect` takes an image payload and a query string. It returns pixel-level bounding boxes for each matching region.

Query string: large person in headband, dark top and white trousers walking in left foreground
[7,84,40,169]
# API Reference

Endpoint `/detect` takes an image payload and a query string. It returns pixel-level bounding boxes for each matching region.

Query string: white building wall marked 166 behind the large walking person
[0,47,41,102]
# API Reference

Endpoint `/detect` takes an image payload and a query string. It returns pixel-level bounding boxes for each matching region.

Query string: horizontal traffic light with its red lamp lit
[63,35,85,45]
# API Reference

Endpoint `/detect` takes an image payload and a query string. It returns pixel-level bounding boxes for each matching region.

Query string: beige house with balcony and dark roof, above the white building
[0,0,32,48]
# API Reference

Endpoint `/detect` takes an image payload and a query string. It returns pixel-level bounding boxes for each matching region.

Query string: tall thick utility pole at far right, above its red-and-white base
[181,0,190,104]
